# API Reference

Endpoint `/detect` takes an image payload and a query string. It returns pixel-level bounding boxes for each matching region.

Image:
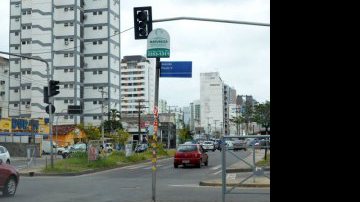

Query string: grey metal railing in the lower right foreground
[221,135,270,202]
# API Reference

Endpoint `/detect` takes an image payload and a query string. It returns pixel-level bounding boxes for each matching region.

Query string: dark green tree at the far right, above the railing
[254,101,270,134]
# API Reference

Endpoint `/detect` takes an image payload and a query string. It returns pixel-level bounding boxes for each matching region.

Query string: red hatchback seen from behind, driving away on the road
[174,144,209,168]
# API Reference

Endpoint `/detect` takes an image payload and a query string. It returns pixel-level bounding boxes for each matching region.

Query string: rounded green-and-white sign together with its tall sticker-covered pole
[147,28,170,202]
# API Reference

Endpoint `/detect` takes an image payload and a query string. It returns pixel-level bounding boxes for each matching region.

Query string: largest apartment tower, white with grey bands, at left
[9,0,120,125]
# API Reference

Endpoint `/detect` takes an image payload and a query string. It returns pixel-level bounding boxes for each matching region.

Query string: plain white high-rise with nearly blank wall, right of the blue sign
[200,72,224,133]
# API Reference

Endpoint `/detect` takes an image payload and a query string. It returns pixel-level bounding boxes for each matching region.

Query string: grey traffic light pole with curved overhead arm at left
[0,51,54,168]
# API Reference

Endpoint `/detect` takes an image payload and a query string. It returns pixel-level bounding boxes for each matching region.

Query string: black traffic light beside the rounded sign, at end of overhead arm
[134,6,152,39]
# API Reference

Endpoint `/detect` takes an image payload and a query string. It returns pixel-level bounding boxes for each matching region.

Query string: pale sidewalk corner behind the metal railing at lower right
[199,150,270,187]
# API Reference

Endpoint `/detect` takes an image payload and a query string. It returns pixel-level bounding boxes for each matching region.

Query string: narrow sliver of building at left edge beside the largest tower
[0,56,9,118]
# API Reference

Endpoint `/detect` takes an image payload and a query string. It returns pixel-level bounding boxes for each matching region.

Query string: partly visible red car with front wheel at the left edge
[0,159,19,196]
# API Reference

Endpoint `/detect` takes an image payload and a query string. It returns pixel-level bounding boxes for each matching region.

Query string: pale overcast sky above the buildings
[0,0,270,107]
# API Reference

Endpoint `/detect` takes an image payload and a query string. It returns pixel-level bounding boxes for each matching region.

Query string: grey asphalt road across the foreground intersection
[0,151,270,202]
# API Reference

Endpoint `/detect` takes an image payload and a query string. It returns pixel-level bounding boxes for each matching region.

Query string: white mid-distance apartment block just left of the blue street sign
[121,55,155,116]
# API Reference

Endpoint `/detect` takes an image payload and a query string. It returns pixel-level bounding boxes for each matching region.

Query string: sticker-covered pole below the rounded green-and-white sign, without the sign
[152,57,160,202]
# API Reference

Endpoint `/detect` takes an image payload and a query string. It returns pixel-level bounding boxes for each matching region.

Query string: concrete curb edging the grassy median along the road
[19,157,172,177]
